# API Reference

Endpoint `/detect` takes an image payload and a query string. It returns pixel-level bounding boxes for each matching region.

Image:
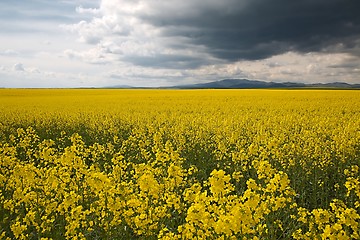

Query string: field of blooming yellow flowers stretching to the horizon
[0,89,360,239]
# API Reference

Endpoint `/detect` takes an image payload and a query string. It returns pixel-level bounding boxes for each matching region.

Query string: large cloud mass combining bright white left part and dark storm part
[65,0,360,69]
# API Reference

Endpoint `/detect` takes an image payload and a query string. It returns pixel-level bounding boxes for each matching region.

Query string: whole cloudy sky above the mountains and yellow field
[0,0,360,87]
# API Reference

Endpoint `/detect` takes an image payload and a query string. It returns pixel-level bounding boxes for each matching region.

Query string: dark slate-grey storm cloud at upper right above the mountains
[141,0,360,61]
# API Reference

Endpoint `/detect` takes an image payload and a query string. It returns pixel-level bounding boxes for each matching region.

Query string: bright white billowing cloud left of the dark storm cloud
[62,0,215,68]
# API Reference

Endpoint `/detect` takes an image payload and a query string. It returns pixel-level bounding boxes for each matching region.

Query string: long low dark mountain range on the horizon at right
[170,79,360,89]
